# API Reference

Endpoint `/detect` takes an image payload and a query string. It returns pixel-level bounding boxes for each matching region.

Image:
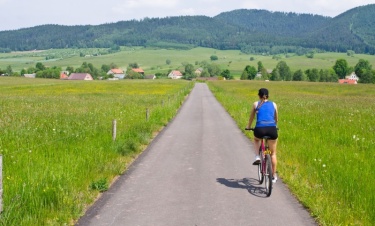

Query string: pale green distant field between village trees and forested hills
[0,47,375,78]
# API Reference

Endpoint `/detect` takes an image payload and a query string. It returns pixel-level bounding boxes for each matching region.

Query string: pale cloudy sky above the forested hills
[0,0,375,31]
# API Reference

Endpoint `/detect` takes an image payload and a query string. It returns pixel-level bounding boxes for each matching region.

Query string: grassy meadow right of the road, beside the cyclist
[208,81,375,225]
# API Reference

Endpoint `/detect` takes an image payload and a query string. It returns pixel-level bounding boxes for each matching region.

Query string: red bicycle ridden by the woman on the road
[245,128,272,197]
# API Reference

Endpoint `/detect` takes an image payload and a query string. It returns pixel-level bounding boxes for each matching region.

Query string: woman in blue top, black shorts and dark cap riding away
[246,88,278,183]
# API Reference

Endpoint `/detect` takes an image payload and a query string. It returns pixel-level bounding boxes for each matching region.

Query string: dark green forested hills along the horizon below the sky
[0,4,375,54]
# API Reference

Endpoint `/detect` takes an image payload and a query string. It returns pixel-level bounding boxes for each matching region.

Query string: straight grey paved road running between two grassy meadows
[77,83,316,226]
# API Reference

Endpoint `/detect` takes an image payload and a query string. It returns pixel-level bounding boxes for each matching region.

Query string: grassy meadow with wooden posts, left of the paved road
[0,77,193,226]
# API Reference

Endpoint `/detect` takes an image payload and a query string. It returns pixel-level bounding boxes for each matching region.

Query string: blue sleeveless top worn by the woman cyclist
[255,101,276,127]
